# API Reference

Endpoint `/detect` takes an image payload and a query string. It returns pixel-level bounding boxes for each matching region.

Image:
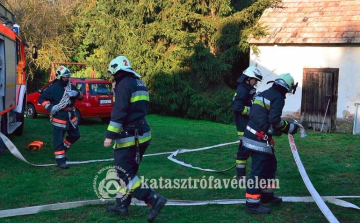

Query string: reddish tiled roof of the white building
[248,0,360,44]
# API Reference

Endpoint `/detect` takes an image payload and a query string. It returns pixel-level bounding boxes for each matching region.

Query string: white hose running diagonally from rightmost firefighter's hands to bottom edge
[288,134,339,223]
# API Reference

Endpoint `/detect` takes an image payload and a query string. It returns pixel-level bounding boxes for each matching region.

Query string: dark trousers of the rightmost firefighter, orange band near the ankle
[245,151,277,208]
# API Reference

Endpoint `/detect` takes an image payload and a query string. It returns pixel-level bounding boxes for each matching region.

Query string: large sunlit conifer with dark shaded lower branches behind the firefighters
[77,0,275,122]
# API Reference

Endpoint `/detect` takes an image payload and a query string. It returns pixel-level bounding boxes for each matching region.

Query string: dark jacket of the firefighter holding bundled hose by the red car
[39,79,84,130]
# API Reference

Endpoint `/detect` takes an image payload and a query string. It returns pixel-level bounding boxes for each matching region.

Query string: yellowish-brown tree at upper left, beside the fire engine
[3,0,82,79]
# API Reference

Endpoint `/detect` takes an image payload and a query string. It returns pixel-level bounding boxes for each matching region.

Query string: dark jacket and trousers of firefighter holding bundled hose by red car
[39,79,84,165]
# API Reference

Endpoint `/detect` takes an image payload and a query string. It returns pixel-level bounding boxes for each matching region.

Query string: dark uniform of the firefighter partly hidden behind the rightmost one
[233,80,256,179]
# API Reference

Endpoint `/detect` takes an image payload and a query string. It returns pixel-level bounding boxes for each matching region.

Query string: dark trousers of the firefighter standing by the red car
[53,125,80,164]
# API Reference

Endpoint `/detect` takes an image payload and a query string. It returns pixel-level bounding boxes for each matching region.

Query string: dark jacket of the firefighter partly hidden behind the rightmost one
[233,82,256,136]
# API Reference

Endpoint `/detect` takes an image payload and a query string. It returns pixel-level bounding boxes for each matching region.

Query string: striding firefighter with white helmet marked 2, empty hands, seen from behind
[104,56,167,222]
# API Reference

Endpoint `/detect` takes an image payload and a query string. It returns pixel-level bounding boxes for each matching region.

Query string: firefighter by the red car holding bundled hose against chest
[39,66,84,169]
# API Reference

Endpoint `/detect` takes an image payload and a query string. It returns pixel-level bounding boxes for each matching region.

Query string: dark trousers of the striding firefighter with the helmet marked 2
[114,143,155,206]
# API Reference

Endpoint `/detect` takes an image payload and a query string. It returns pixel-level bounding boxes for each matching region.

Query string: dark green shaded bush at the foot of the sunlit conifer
[148,70,234,124]
